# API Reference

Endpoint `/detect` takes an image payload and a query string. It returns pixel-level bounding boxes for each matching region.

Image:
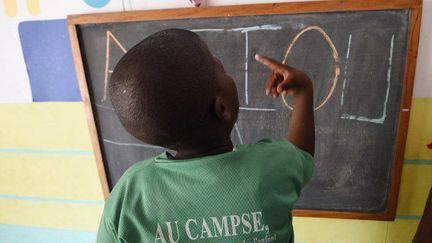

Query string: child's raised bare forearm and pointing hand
[255,55,315,155]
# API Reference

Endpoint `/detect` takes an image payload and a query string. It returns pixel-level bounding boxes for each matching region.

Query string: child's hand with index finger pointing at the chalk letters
[255,54,312,98]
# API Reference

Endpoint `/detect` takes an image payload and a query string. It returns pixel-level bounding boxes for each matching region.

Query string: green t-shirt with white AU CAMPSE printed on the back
[97,139,313,243]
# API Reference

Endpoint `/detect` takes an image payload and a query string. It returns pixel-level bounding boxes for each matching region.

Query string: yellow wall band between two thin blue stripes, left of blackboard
[0,153,103,200]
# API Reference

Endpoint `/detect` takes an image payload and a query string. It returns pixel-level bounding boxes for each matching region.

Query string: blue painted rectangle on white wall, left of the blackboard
[18,19,81,101]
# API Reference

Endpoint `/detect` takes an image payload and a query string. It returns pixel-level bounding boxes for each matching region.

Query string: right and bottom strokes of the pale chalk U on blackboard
[341,34,394,124]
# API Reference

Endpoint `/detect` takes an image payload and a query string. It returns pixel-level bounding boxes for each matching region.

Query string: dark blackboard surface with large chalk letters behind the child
[68,0,422,219]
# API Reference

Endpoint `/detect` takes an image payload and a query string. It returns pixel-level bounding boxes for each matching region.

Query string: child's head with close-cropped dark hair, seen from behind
[109,29,238,150]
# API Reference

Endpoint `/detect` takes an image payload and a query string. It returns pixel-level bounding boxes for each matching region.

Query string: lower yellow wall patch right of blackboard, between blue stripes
[397,164,432,215]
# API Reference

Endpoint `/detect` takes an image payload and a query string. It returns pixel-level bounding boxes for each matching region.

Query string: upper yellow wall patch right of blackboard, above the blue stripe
[405,98,432,160]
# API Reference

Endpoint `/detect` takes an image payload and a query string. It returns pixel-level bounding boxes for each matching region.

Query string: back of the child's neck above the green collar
[174,139,234,159]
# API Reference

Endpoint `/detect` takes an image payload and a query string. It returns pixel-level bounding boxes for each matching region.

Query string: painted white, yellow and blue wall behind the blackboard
[0,0,432,243]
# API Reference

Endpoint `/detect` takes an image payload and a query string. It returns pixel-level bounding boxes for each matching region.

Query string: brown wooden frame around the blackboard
[68,0,422,220]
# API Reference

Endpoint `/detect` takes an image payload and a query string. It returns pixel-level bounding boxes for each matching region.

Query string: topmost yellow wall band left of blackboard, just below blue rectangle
[0,102,93,151]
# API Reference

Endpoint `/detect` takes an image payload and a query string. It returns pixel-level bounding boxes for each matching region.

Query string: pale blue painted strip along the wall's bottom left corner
[0,224,96,243]
